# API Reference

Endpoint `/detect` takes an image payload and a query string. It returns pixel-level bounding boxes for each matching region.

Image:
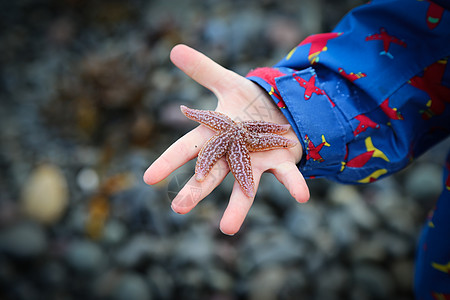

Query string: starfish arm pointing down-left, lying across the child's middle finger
[195,131,230,181]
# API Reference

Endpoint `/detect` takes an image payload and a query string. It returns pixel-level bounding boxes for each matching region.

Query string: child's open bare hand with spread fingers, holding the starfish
[144,45,309,235]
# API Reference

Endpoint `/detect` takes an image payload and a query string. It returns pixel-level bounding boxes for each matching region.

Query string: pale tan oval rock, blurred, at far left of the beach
[21,164,69,224]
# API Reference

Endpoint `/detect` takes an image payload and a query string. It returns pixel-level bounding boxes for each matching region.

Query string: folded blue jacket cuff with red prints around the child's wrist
[247,68,351,178]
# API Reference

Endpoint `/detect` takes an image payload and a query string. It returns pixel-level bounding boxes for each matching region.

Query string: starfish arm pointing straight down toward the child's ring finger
[226,140,255,198]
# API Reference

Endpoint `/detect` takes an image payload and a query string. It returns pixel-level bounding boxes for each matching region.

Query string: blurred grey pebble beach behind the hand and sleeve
[0,0,448,300]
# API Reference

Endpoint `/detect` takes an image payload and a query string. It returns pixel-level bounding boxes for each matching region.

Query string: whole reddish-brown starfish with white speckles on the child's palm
[180,105,297,198]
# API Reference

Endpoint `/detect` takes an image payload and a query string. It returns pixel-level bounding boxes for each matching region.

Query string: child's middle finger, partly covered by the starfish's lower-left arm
[172,159,229,214]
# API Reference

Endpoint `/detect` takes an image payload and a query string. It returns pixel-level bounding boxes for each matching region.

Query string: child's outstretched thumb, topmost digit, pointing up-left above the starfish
[170,45,234,95]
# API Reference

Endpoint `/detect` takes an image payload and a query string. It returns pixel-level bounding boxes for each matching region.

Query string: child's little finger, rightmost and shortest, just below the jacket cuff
[271,161,309,203]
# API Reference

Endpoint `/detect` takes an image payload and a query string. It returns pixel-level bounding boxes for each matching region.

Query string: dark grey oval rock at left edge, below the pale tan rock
[0,222,47,259]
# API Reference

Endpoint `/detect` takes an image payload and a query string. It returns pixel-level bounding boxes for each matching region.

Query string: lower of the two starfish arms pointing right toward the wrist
[246,133,297,152]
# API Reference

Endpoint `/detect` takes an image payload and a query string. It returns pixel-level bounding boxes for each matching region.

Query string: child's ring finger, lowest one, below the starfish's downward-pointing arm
[220,172,262,235]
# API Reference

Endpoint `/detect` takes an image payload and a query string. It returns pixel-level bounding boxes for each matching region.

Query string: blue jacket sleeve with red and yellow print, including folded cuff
[247,0,450,183]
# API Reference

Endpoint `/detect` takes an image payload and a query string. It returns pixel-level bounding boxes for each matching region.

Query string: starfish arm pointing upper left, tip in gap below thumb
[180,105,234,132]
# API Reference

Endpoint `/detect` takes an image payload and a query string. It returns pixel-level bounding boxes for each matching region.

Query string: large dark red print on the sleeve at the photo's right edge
[409,59,450,120]
